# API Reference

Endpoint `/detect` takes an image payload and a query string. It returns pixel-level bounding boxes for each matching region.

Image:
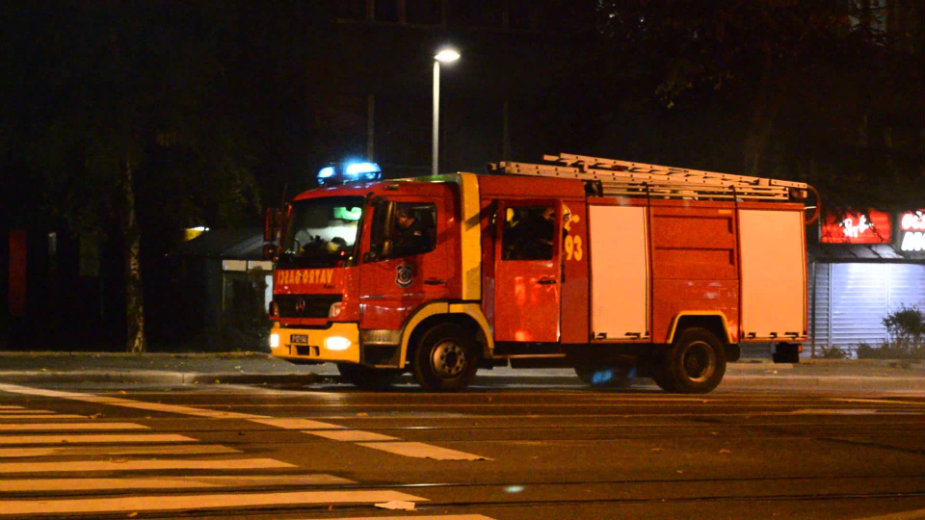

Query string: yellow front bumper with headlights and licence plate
[270,322,360,363]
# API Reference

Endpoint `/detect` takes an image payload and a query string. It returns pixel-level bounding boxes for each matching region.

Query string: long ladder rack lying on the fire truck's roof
[488,153,811,202]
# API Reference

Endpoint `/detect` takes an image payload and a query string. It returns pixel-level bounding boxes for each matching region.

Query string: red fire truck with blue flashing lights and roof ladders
[266,154,812,393]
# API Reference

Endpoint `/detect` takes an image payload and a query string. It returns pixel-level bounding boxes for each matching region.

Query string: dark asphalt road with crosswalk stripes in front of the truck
[0,380,925,520]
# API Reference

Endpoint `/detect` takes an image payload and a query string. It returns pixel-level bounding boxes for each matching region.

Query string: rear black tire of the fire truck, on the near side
[653,327,726,394]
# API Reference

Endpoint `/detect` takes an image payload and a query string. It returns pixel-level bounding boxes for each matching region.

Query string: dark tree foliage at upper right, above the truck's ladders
[599,0,925,207]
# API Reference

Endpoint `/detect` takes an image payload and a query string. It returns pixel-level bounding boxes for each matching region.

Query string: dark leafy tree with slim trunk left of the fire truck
[4,2,259,352]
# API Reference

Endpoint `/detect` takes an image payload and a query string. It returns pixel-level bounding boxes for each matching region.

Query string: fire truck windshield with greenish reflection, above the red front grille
[279,197,364,268]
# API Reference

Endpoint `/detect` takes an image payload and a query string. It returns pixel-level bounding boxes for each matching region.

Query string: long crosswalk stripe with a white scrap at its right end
[0,490,426,516]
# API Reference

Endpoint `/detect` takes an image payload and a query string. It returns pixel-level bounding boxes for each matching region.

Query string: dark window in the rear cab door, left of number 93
[501,206,556,260]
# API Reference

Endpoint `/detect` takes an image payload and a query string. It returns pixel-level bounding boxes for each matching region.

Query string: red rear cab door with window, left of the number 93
[494,200,562,342]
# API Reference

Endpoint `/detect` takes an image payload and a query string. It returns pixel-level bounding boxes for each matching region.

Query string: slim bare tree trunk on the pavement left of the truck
[122,160,147,354]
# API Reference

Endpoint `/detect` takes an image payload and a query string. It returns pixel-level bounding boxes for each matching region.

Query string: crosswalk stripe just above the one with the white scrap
[0,473,355,493]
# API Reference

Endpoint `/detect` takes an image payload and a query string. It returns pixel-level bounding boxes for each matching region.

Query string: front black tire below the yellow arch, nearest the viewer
[412,323,479,392]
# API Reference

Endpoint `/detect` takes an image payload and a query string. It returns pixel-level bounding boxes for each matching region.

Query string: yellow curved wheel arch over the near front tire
[400,302,495,366]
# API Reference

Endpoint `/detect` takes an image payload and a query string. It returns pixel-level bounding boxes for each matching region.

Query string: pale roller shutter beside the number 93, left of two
[588,206,649,340]
